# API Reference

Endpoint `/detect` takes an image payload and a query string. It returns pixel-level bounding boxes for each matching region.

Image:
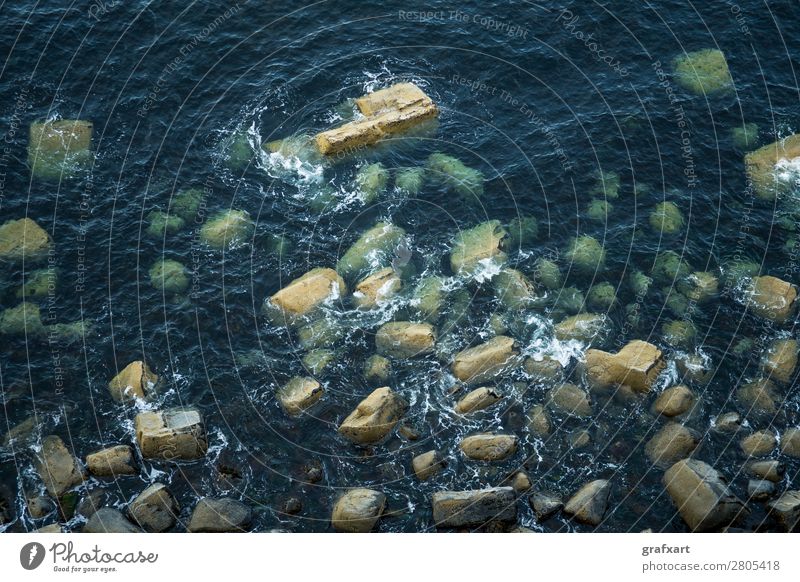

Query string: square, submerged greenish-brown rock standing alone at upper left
[28,119,93,180]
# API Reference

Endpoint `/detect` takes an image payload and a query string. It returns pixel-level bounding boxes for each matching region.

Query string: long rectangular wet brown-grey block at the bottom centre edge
[432,487,517,528]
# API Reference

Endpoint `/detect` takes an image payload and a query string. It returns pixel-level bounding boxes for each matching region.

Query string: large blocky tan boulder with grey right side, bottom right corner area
[664,459,744,531]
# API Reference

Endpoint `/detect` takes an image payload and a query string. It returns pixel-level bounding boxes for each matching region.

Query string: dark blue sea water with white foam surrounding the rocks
[0,0,800,531]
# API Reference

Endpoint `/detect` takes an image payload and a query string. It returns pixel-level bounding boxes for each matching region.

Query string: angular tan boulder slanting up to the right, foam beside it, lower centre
[339,387,408,444]
